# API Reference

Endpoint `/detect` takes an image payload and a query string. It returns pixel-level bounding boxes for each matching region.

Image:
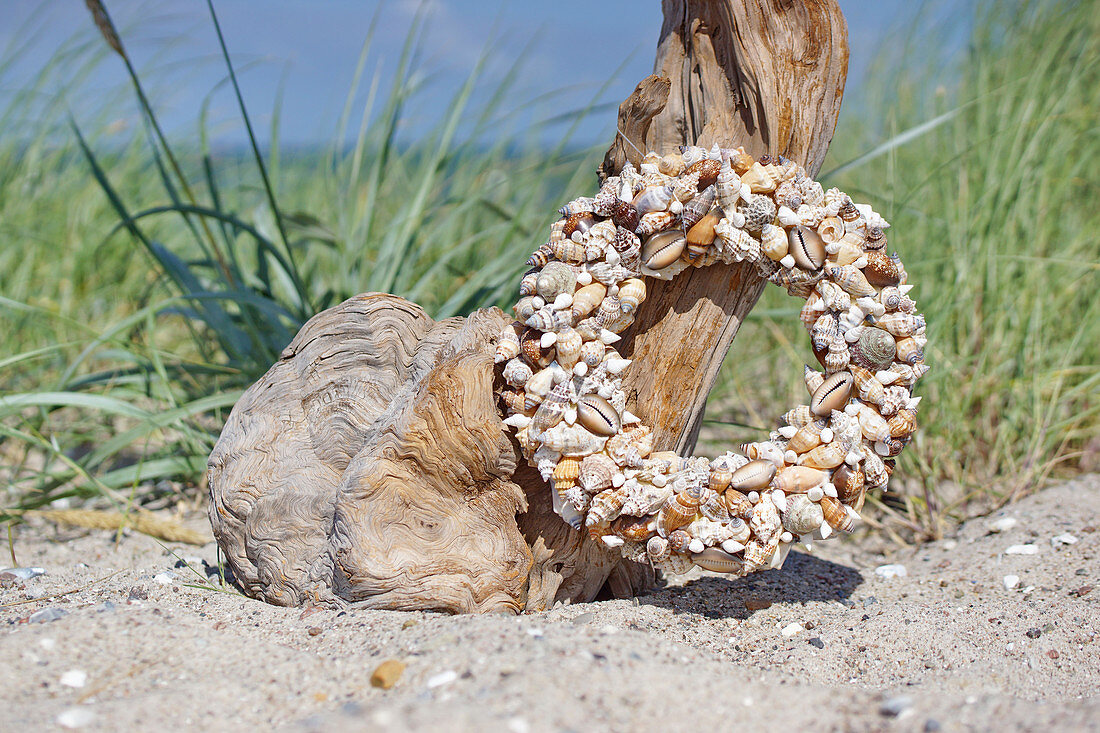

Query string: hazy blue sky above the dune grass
[0,0,937,145]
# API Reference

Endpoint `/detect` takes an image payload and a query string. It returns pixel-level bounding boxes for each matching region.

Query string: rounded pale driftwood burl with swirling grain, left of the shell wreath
[209,294,557,612]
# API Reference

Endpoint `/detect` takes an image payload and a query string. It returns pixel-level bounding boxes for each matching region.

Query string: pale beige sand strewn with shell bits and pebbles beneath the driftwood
[0,475,1100,733]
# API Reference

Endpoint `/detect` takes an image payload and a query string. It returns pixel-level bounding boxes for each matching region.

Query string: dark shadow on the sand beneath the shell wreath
[638,551,864,621]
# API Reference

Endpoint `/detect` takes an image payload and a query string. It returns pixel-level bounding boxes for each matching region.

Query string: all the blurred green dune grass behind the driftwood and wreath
[0,2,1100,535]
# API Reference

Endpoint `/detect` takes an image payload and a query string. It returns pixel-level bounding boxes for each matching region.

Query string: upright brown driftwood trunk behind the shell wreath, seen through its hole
[601,0,848,455]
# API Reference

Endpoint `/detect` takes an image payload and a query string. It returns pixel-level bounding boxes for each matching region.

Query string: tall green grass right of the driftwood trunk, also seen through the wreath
[715,2,1100,535]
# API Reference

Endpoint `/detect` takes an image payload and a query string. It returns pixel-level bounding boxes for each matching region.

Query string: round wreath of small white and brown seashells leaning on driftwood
[496,145,928,576]
